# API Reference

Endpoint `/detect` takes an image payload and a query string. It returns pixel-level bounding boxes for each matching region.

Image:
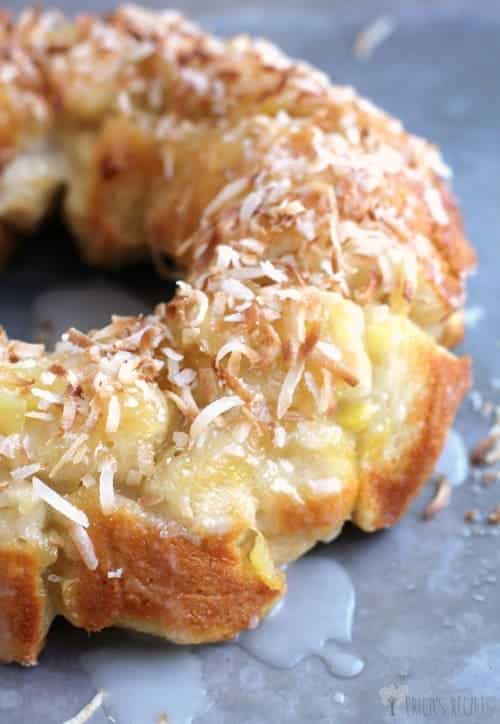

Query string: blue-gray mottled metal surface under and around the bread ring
[0,0,500,724]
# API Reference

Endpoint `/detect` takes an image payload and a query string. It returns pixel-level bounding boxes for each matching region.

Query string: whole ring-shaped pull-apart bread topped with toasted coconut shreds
[0,7,474,664]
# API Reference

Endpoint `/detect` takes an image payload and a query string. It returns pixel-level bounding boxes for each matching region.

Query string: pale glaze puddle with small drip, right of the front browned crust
[238,554,364,678]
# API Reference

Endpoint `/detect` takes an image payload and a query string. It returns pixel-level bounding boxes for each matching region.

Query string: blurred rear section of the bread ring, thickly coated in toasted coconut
[0,6,474,344]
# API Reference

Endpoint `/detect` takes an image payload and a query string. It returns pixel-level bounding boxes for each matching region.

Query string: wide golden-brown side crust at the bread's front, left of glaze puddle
[54,494,285,643]
